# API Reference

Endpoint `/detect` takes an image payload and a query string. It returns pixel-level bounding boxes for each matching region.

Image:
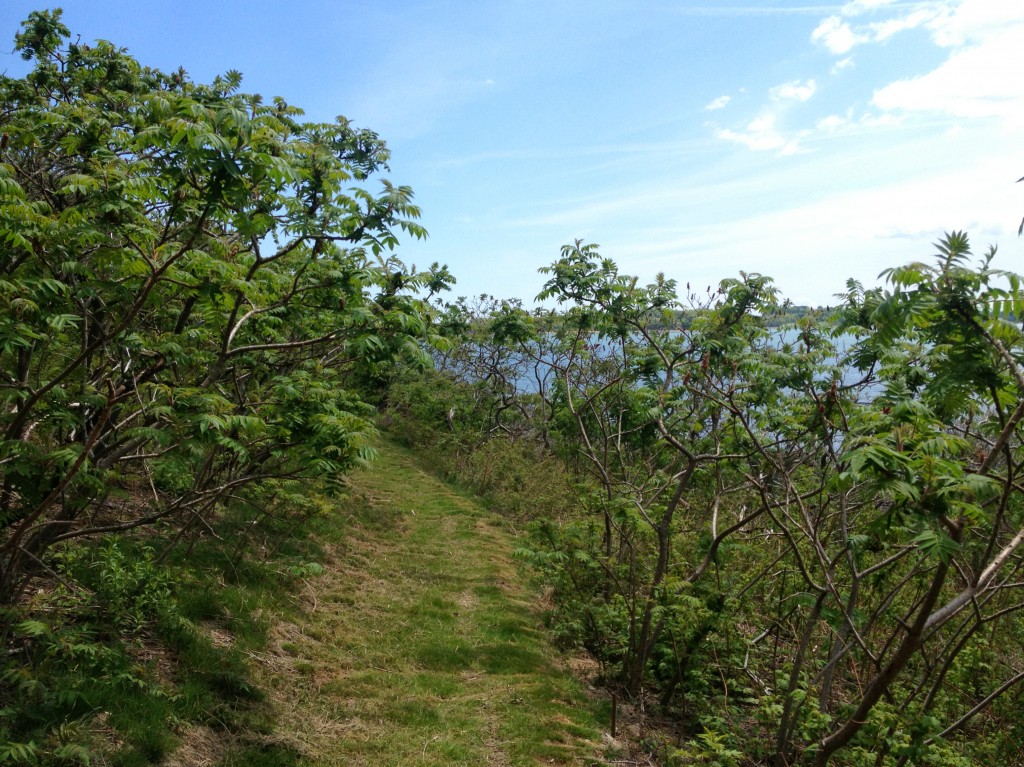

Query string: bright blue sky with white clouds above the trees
[0,0,1024,304]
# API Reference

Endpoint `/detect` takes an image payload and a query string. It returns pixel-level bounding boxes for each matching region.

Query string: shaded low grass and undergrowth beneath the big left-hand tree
[0,491,335,767]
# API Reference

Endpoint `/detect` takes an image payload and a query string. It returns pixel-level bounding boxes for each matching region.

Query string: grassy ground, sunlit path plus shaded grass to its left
[0,434,608,767]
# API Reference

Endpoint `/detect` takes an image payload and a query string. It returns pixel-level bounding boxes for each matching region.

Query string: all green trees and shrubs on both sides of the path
[6,12,1024,767]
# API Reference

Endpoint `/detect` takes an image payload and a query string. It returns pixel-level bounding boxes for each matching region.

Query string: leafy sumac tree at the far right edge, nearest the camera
[794,232,1024,767]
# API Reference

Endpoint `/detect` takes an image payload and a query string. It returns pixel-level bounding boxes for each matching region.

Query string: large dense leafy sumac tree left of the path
[0,11,451,603]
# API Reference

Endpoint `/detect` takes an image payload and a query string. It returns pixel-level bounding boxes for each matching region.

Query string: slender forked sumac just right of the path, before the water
[540,242,777,696]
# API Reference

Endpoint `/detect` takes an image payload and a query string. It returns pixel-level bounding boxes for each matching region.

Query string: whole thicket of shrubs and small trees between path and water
[380,242,1024,767]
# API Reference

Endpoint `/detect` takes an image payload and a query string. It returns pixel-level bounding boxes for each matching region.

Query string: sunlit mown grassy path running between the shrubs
[262,436,607,767]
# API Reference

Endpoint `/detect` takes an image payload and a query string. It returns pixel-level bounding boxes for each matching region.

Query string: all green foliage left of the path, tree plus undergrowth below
[0,11,454,765]
